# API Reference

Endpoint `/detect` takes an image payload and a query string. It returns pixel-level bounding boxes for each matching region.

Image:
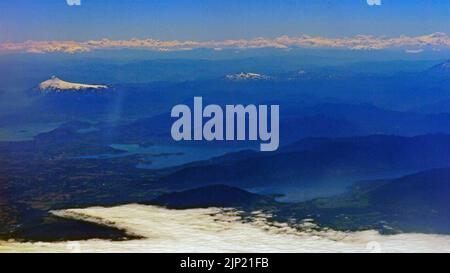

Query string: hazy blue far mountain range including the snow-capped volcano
[0,56,450,125]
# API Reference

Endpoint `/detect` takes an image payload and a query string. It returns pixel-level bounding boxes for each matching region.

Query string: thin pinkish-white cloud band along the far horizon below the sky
[0,32,450,54]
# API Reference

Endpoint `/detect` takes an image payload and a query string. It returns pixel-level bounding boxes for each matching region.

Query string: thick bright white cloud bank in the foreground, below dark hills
[0,204,450,253]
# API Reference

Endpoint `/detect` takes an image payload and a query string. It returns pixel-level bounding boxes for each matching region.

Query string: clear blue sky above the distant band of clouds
[0,0,450,42]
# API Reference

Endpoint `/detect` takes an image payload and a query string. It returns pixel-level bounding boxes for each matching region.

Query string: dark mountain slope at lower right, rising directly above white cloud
[277,168,450,234]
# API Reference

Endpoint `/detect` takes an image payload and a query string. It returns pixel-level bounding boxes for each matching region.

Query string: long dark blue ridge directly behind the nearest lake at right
[161,134,450,194]
